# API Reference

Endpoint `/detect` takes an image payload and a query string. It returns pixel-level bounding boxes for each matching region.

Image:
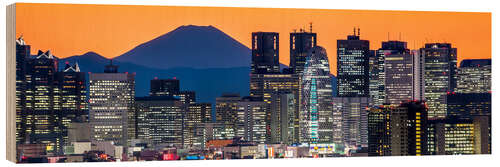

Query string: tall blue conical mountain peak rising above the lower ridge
[114,25,251,69]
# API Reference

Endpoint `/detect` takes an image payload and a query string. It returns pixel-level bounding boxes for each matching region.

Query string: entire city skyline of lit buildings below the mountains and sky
[16,25,491,162]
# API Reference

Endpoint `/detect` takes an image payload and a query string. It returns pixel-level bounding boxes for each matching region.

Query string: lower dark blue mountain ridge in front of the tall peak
[60,52,250,104]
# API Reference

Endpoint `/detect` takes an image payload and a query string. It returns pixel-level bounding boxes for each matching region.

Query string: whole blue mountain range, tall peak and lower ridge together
[60,25,336,104]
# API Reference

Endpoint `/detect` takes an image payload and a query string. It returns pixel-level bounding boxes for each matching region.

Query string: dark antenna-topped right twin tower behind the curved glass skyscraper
[290,25,317,74]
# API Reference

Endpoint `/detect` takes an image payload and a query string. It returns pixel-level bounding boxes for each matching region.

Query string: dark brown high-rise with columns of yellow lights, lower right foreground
[368,101,428,156]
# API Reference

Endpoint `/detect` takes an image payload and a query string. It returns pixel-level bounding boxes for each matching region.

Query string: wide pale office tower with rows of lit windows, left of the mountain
[89,63,135,146]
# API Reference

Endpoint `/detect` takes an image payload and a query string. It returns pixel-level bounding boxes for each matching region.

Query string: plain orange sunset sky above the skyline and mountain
[16,3,491,74]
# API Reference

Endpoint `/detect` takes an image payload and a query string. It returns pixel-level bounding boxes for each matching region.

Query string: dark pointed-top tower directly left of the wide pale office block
[54,63,88,145]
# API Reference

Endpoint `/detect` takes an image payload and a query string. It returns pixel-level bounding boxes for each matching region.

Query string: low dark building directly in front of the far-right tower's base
[446,92,491,119]
